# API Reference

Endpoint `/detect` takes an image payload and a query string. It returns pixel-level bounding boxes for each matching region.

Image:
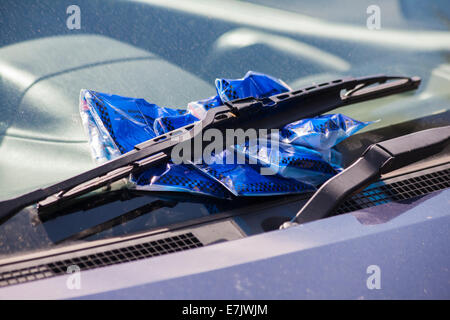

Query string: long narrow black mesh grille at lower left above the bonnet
[0,232,203,287]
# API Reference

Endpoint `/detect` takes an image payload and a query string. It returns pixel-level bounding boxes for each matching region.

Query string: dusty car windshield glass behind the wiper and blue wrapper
[0,0,450,256]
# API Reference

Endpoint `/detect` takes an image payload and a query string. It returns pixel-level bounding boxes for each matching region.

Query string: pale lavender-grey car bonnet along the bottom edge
[0,189,450,299]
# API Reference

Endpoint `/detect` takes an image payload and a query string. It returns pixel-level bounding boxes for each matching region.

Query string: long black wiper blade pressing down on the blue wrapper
[0,75,420,222]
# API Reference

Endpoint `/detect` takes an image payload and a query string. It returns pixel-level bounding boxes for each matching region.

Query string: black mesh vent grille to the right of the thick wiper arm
[335,169,450,214]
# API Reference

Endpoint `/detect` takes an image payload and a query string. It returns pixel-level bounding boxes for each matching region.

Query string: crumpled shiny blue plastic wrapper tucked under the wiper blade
[80,71,369,199]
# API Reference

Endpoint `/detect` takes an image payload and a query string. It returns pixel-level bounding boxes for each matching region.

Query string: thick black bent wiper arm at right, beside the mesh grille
[280,126,450,229]
